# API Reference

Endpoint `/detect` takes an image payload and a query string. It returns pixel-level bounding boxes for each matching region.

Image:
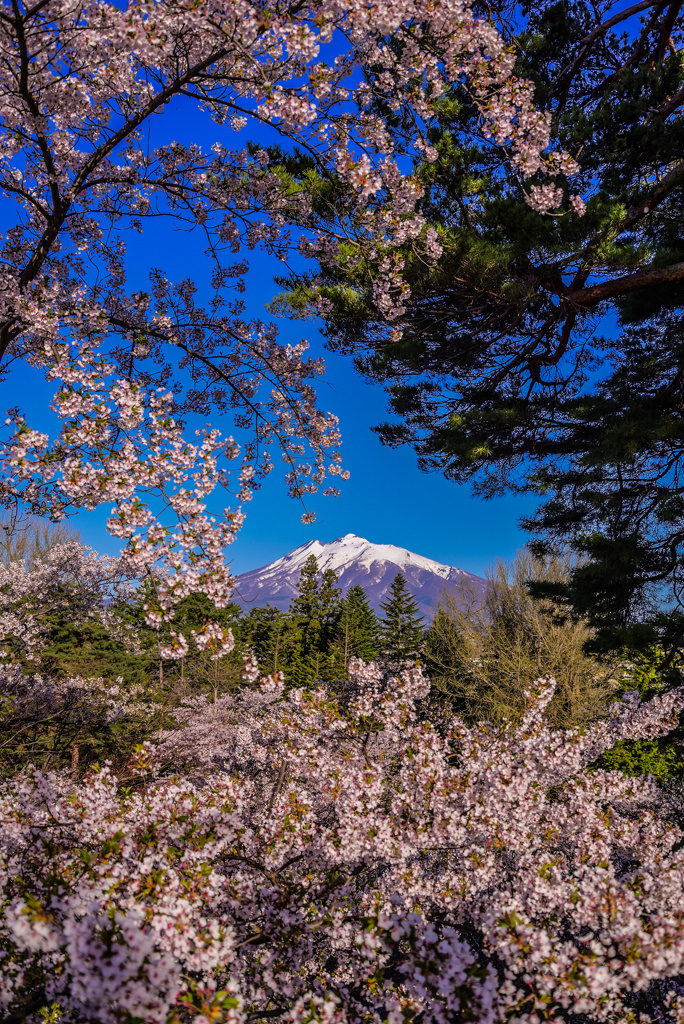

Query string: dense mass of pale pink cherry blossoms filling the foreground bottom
[0,663,684,1024]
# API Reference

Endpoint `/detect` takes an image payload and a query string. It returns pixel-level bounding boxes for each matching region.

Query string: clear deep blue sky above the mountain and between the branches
[6,99,535,574]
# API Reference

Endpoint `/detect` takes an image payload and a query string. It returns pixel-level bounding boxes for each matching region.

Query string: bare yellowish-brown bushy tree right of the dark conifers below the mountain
[424,552,619,728]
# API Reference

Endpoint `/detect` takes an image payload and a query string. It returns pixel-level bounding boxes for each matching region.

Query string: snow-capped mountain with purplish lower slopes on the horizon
[233,534,486,618]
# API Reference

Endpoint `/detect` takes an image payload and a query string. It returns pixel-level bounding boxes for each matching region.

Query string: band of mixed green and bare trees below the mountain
[0,512,683,778]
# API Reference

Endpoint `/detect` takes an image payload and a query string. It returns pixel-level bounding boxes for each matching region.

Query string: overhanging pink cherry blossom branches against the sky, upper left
[0,0,575,621]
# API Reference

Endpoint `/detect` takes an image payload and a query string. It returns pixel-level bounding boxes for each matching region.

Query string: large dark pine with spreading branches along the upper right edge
[273,0,684,653]
